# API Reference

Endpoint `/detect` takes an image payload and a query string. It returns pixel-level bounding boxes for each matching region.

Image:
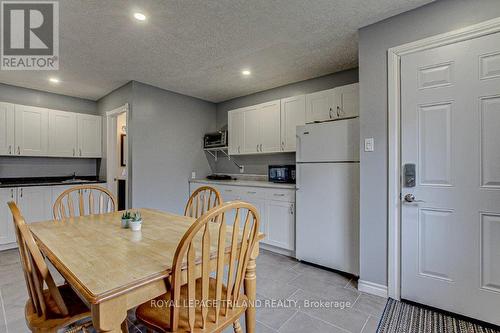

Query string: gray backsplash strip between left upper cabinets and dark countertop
[0,157,97,178]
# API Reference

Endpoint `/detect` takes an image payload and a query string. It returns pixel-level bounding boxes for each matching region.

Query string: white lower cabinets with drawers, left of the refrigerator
[189,183,295,252]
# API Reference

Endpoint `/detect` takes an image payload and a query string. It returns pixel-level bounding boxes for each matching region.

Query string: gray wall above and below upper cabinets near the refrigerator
[215,68,358,174]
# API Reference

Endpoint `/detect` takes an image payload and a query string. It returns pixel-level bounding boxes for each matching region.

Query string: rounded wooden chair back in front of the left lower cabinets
[52,185,117,220]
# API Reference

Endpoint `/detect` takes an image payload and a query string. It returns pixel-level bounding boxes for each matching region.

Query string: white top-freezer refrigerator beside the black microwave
[296,117,359,276]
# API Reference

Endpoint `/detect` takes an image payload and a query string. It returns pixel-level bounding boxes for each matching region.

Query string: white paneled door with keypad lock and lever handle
[401,33,500,325]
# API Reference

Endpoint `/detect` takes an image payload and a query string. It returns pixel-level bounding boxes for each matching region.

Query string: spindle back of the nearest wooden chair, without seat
[170,201,260,332]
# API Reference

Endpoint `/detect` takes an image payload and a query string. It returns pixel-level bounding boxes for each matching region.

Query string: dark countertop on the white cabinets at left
[0,176,106,188]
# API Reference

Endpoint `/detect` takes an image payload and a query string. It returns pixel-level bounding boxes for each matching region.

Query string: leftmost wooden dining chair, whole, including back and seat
[8,201,90,332]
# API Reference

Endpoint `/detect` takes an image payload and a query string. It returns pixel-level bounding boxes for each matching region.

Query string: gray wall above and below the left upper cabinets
[0,83,97,178]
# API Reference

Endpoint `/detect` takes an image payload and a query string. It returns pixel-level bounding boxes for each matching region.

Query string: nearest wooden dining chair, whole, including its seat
[136,201,260,333]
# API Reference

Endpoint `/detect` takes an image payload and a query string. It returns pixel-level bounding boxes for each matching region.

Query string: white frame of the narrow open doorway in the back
[106,103,130,207]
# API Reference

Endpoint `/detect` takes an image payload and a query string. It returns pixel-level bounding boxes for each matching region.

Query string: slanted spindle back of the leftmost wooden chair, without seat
[8,201,68,317]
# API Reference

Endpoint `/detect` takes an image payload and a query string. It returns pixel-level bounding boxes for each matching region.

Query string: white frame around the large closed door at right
[387,18,500,300]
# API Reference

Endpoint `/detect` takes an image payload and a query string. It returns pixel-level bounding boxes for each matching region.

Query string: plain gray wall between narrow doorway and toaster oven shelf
[128,82,216,214]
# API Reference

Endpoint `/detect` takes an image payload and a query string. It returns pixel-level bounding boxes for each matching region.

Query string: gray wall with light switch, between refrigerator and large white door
[359,0,500,285]
